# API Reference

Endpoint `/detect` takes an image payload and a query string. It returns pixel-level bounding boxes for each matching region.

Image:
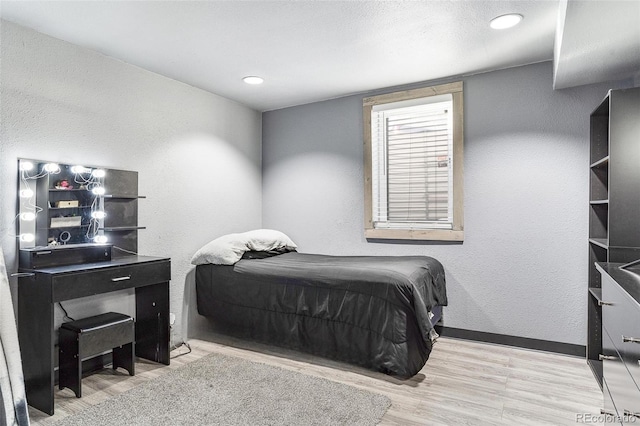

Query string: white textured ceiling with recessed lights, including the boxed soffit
[0,0,640,111]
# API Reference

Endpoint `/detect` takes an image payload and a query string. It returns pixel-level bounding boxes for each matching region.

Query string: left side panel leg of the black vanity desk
[18,277,55,415]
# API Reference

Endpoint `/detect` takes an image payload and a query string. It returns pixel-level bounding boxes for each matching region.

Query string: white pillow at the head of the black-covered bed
[191,229,298,265]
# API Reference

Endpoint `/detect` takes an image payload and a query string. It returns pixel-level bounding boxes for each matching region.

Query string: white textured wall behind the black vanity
[0,21,262,341]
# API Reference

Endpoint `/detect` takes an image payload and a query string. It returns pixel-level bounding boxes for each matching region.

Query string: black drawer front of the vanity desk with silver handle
[52,261,171,302]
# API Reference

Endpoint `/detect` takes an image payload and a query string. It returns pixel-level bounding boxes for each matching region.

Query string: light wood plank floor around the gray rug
[29,335,602,426]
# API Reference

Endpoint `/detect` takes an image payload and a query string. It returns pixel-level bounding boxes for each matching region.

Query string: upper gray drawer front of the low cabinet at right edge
[602,275,640,392]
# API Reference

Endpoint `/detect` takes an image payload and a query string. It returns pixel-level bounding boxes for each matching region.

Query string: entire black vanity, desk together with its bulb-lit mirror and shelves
[18,158,171,415]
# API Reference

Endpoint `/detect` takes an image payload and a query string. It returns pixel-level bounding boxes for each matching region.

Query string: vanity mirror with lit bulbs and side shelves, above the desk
[17,158,144,254]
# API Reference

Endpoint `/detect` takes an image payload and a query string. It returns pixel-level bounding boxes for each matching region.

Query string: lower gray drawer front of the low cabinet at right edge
[602,330,640,424]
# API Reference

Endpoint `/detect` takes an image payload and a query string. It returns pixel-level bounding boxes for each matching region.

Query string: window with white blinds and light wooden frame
[363,82,464,241]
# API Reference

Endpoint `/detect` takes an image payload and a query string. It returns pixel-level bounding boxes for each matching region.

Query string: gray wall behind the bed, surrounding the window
[262,62,628,345]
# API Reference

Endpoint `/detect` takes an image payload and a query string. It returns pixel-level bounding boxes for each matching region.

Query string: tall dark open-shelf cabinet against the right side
[586,88,640,387]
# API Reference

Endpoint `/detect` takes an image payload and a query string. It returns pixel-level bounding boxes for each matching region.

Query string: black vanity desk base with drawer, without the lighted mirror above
[18,251,171,415]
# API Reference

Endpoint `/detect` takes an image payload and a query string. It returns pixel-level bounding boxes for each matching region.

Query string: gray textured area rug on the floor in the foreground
[55,354,391,426]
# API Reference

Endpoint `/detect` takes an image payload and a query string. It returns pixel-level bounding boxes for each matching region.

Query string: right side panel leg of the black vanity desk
[135,282,170,365]
